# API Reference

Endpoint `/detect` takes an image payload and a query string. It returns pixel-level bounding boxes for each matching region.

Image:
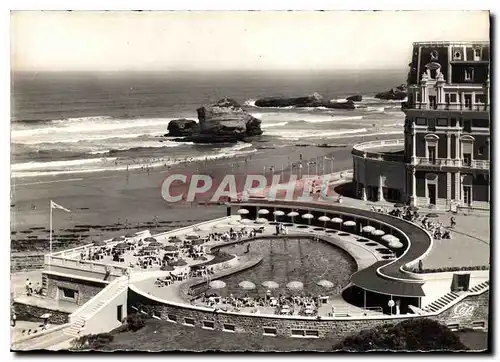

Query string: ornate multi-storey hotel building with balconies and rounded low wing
[353,42,490,209]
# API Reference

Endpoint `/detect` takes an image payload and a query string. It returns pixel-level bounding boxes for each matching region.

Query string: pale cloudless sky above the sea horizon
[11,10,489,71]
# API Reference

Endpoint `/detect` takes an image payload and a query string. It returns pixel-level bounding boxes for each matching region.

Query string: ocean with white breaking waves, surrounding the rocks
[11,69,406,177]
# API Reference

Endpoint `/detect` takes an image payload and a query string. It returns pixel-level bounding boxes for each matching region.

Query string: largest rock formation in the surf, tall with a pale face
[168,97,262,143]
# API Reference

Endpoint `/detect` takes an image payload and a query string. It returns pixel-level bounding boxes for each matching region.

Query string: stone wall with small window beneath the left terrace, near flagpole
[43,273,108,305]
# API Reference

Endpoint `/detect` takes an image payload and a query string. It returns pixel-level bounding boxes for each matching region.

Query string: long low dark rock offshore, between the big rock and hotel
[255,93,356,109]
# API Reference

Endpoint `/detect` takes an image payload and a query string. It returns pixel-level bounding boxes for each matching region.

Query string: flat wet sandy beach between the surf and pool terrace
[11,135,398,253]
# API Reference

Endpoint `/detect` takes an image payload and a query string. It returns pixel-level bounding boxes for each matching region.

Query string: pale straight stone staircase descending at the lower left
[64,277,128,338]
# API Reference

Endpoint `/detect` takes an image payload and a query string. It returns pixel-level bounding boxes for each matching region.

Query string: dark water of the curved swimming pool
[214,238,356,296]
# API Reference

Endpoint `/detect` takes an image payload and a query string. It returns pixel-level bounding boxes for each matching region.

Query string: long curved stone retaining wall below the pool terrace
[128,289,488,338]
